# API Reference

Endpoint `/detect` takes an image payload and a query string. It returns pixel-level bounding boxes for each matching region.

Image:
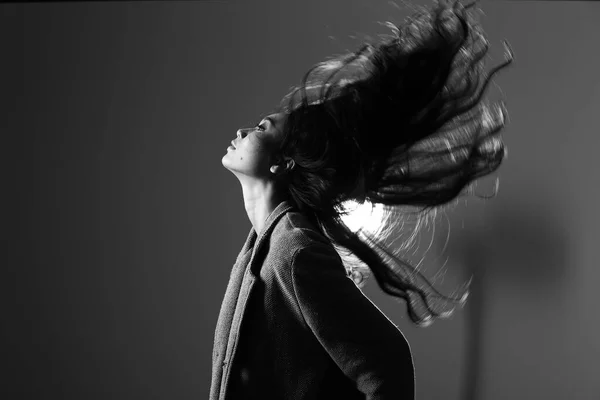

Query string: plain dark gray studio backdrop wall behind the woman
[0,0,600,400]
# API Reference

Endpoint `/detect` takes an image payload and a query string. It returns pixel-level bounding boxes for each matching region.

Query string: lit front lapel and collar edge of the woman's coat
[210,201,292,400]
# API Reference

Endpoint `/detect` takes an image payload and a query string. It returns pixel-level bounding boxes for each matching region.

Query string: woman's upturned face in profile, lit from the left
[221,113,284,178]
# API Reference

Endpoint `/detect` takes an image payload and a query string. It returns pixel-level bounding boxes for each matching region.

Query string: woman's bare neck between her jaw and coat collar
[242,182,285,236]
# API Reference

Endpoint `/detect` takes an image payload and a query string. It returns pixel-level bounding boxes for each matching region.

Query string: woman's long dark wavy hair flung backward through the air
[276,0,512,326]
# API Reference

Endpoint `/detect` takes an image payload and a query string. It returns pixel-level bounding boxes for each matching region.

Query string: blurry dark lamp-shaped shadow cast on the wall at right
[451,199,567,400]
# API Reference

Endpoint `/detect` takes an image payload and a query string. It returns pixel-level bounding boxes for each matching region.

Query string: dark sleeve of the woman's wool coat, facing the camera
[292,243,415,400]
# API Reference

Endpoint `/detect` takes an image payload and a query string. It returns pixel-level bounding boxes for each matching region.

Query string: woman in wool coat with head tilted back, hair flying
[210,2,512,400]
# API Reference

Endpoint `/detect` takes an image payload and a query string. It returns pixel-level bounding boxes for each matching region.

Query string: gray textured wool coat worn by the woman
[210,201,415,400]
